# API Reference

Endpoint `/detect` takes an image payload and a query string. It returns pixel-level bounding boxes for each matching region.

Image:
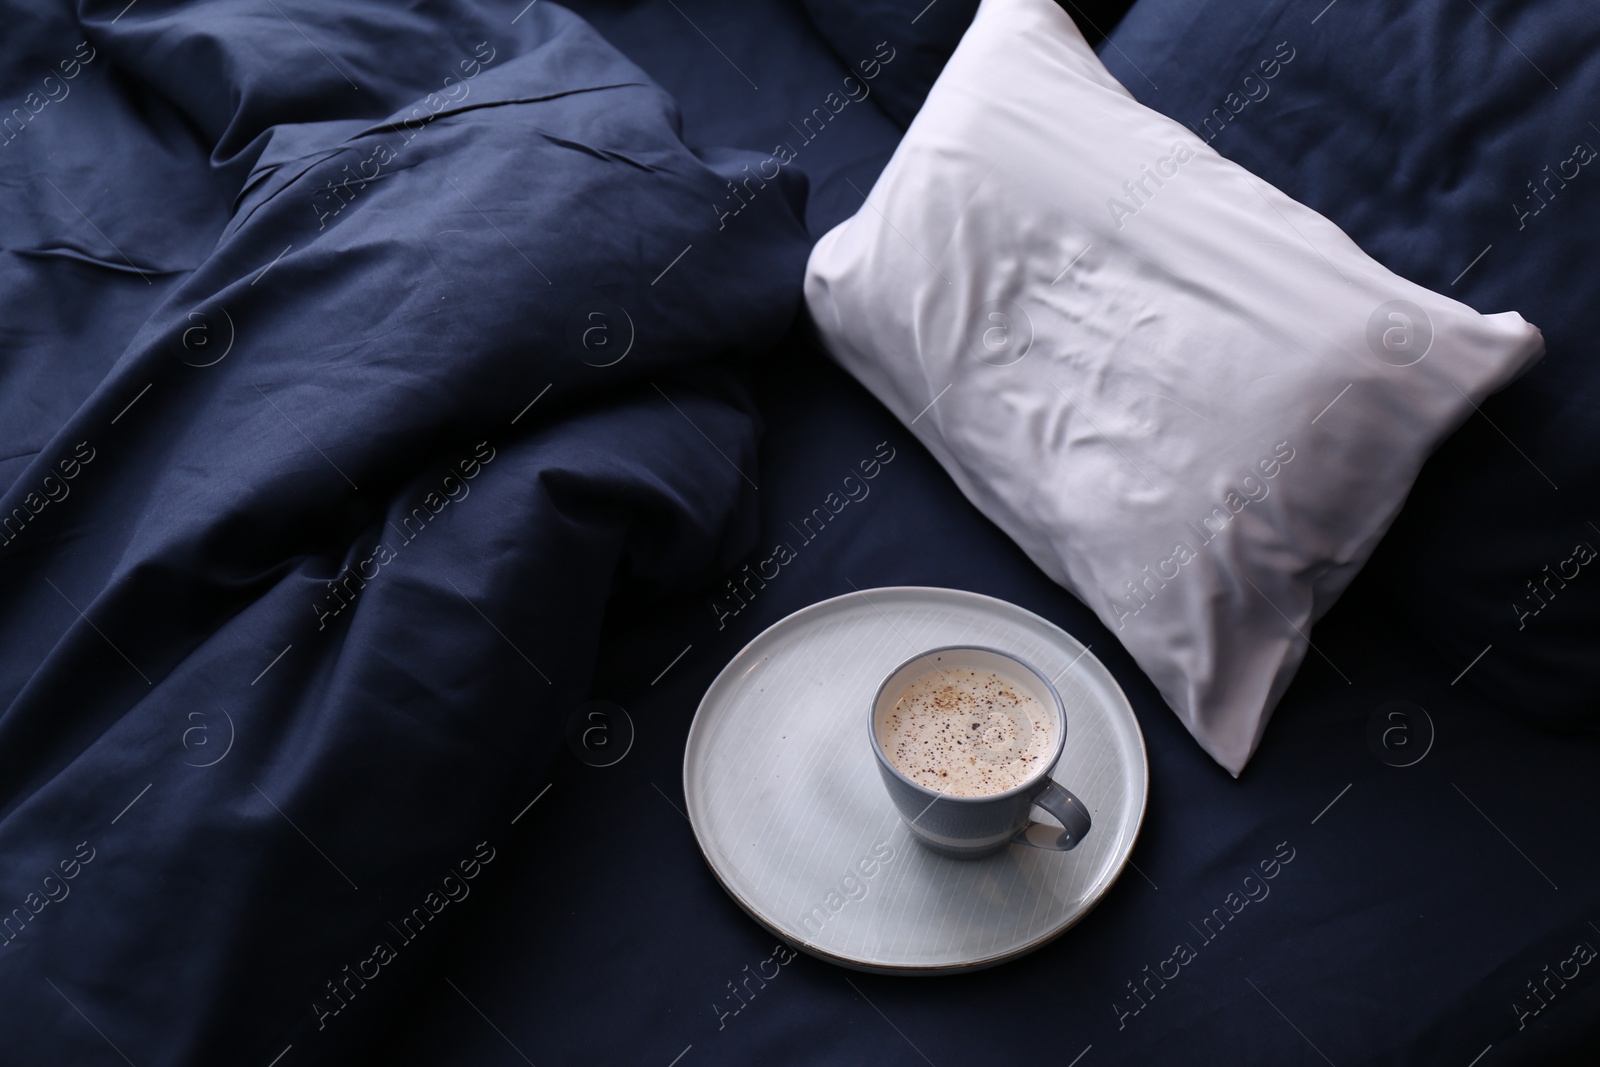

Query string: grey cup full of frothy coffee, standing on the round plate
[867,646,1090,856]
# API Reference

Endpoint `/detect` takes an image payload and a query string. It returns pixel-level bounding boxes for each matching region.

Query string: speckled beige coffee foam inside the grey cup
[878,667,1056,797]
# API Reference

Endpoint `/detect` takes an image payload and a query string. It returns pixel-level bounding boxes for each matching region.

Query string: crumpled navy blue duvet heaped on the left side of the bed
[0,0,808,1064]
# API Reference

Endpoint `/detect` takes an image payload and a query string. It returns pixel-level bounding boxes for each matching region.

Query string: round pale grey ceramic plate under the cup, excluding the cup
[683,587,1149,974]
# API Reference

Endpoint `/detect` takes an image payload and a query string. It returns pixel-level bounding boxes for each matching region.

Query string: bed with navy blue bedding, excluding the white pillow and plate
[0,0,1600,1067]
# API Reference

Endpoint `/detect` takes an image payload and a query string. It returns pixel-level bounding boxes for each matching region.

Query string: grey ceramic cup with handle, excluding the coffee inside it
[867,646,1090,856]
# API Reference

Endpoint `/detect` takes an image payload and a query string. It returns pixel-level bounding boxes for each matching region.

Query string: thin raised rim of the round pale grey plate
[682,585,1150,977]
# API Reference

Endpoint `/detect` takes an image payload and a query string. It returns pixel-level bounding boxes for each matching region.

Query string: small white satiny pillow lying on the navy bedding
[806,0,1544,776]
